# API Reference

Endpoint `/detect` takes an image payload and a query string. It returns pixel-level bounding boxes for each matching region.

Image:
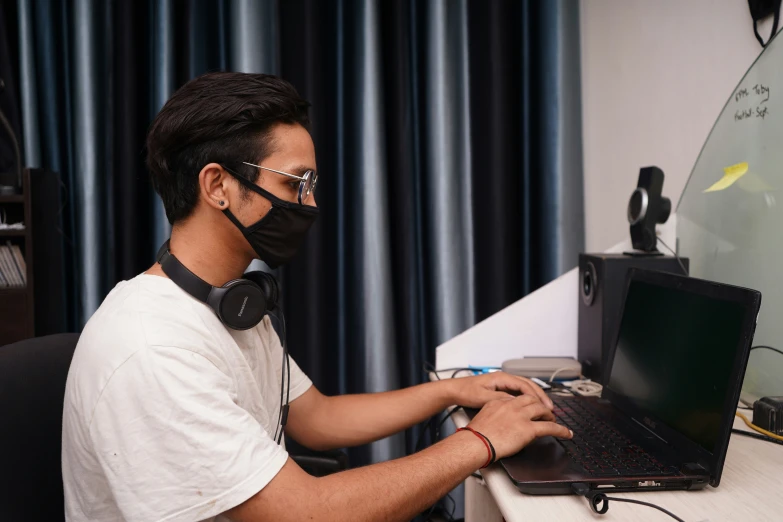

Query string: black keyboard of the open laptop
[552,397,679,477]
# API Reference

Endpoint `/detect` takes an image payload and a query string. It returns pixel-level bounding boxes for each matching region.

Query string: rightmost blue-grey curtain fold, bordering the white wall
[530,0,584,282]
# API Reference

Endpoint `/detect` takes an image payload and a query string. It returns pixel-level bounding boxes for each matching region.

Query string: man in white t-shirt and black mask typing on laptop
[63,73,570,522]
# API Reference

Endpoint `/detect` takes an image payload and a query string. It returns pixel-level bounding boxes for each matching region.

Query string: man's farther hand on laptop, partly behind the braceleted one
[446,372,553,410]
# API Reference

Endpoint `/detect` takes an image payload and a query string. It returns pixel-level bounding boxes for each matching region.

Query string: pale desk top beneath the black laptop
[452,410,783,522]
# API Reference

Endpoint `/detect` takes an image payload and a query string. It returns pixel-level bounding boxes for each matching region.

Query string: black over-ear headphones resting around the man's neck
[156,240,280,330]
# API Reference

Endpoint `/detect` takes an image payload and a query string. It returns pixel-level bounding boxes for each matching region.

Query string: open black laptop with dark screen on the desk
[468,269,761,494]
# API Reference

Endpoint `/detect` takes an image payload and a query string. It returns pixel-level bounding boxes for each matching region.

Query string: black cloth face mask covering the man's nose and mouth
[223,175,318,268]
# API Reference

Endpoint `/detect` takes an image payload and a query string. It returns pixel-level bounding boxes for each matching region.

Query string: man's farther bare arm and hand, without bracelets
[286,372,552,451]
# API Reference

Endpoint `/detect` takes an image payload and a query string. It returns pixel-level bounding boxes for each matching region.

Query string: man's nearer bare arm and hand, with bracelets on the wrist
[226,396,570,522]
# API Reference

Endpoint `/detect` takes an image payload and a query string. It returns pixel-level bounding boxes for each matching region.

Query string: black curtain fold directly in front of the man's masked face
[280,0,348,395]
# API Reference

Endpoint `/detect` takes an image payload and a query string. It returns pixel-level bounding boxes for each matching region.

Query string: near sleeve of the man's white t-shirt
[90,347,293,522]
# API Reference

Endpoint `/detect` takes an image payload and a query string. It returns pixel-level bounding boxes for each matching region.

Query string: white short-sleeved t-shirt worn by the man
[62,274,312,522]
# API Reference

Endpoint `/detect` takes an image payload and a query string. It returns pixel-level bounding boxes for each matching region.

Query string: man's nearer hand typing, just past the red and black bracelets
[468,395,573,459]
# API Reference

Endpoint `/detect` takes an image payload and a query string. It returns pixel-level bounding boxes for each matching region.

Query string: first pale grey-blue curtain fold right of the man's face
[352,0,403,462]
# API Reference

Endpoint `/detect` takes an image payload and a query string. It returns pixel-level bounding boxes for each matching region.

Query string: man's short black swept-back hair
[147,72,310,224]
